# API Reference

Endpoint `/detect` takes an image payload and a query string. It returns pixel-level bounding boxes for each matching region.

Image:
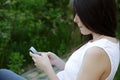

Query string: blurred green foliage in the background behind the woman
[0,0,120,80]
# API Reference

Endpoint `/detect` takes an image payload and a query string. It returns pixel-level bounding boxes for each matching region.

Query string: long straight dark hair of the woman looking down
[73,0,117,40]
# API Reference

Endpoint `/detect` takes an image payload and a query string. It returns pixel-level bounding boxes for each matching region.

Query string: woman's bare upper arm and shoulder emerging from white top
[77,47,108,80]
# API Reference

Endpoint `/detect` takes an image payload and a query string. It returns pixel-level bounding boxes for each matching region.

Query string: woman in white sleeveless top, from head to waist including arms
[30,0,120,80]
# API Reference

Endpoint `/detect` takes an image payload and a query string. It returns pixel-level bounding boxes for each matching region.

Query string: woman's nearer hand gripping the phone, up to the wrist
[30,52,51,71]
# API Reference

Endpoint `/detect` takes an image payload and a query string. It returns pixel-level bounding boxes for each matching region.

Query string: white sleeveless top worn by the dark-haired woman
[57,39,120,80]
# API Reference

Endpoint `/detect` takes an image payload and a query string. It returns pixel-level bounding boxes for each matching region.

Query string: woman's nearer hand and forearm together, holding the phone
[30,52,59,80]
